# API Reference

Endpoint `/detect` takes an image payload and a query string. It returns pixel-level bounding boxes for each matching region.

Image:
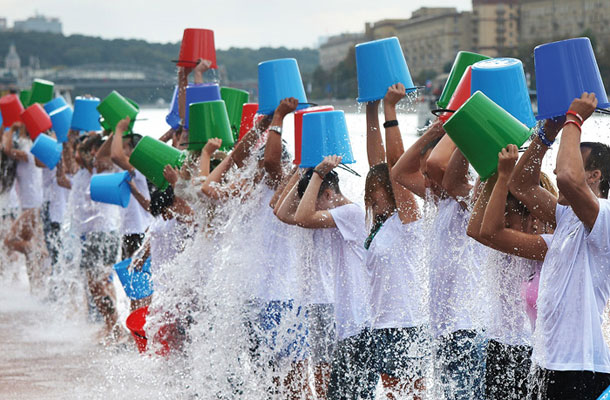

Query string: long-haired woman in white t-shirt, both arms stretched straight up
[364,83,429,399]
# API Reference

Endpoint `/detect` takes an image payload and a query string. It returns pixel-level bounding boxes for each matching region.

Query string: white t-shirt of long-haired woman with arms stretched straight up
[366,213,427,329]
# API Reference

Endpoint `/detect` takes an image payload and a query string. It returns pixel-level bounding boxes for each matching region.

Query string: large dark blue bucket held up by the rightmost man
[534,38,610,120]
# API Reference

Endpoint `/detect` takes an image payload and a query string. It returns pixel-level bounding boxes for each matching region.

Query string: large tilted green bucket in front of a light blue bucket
[444,91,531,180]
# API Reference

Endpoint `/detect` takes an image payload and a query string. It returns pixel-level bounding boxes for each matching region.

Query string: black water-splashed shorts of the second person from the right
[485,340,532,400]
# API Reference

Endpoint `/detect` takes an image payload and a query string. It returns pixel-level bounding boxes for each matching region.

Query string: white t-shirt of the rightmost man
[533,199,610,373]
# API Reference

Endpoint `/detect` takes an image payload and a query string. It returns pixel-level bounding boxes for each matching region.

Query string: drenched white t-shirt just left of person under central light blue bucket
[257,186,299,301]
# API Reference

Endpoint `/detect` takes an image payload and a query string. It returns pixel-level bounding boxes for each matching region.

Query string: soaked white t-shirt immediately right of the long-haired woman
[428,198,488,336]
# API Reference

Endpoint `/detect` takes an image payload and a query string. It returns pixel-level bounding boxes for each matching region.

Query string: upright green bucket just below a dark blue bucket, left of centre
[188,100,234,151]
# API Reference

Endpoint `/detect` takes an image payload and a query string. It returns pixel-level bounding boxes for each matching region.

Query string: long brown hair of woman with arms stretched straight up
[364,163,396,248]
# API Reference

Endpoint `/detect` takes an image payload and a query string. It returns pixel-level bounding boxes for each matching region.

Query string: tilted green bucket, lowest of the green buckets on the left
[129,136,186,190]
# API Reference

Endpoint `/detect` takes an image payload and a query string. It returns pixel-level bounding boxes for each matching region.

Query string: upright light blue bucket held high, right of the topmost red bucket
[257,58,309,115]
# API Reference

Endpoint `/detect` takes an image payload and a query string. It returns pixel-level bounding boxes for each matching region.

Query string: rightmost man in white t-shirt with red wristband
[509,92,610,399]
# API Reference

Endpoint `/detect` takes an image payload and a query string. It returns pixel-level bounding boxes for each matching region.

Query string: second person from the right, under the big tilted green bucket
[468,145,556,400]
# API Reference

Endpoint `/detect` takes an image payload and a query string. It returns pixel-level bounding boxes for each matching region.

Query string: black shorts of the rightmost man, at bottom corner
[528,367,610,400]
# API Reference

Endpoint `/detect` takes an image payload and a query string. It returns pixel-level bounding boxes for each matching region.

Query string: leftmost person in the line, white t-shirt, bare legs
[2,122,48,292]
